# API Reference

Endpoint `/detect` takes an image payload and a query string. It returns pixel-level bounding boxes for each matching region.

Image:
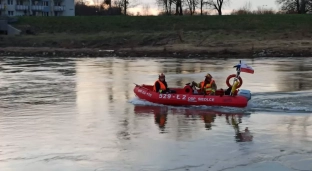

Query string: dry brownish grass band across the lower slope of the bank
[0,30,312,49]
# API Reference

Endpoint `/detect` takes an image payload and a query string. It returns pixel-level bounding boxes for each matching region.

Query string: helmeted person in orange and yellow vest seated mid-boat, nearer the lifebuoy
[192,73,217,95]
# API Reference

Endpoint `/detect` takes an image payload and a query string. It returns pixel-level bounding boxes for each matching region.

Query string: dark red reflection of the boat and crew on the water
[134,105,253,142]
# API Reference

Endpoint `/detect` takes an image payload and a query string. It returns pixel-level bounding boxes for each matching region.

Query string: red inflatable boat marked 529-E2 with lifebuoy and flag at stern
[134,62,253,108]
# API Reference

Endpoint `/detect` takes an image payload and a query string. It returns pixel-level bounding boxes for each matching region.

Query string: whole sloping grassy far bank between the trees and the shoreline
[0,15,312,56]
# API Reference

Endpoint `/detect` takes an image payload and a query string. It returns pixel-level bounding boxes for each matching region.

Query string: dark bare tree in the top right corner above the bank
[276,0,312,14]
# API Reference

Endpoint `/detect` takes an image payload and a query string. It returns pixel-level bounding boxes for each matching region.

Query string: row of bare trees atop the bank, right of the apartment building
[75,0,312,16]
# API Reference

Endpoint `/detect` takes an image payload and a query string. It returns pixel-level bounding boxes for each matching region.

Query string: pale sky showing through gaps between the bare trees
[130,0,278,14]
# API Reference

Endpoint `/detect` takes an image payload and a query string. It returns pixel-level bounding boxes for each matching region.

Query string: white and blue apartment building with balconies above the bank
[0,0,75,16]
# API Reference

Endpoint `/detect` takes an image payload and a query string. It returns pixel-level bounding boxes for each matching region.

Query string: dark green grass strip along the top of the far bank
[10,15,312,34]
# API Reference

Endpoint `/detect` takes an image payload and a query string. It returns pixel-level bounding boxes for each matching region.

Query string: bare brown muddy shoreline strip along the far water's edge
[0,40,312,58]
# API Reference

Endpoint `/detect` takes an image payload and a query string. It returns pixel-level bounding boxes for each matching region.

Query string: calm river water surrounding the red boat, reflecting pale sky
[0,57,312,171]
